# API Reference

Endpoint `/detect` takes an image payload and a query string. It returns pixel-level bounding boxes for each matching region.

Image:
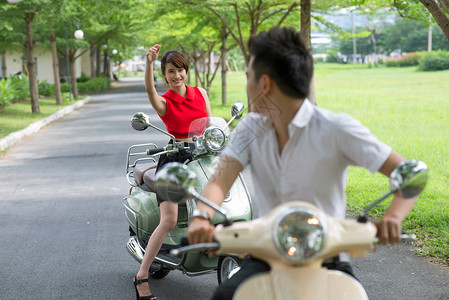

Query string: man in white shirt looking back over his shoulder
[187,28,416,299]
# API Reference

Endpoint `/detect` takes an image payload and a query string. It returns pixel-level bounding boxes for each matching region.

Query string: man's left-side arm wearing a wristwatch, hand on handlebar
[187,156,243,244]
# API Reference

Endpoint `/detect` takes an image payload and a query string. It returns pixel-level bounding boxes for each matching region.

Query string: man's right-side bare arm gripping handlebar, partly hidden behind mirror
[374,151,418,244]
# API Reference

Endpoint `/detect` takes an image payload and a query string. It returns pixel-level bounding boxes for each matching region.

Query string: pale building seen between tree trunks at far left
[0,45,90,84]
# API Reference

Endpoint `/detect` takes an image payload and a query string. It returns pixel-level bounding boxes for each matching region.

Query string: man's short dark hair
[248,27,313,99]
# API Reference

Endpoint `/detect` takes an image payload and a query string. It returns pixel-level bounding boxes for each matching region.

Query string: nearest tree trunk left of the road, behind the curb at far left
[25,13,41,114]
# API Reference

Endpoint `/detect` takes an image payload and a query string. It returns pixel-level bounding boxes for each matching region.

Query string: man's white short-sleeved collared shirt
[222,100,391,219]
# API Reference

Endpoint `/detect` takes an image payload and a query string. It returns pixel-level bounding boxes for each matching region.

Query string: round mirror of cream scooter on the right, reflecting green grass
[390,159,429,199]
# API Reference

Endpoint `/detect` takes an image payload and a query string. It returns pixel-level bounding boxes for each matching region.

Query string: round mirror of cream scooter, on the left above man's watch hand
[155,162,198,203]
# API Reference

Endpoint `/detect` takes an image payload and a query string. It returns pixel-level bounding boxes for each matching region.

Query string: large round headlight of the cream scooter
[273,207,327,262]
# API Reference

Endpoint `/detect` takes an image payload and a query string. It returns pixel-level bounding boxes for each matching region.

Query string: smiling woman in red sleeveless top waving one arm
[133,45,212,300]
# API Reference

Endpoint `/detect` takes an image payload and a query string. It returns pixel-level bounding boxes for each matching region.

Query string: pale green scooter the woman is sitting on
[123,102,253,284]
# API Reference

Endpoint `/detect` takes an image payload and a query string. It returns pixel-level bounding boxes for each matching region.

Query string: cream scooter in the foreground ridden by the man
[156,160,428,300]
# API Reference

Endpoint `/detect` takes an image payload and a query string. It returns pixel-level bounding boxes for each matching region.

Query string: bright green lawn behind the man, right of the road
[210,64,449,263]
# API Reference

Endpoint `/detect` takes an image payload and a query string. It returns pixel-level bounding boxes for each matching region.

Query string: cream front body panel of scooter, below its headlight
[233,267,368,300]
